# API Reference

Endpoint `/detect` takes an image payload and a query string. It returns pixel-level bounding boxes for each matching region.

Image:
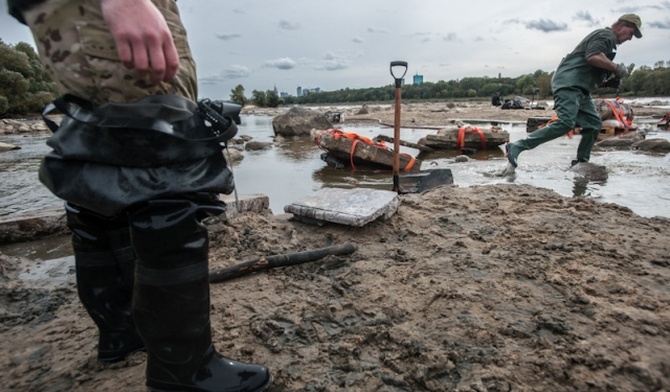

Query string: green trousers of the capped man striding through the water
[510,88,602,162]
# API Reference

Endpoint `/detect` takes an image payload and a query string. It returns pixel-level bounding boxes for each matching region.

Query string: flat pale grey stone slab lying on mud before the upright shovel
[284,188,400,227]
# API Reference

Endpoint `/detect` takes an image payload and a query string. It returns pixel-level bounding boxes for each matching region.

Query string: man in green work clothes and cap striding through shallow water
[505,14,642,167]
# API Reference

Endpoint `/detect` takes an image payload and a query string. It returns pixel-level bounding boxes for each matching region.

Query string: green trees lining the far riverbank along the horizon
[0,39,670,116]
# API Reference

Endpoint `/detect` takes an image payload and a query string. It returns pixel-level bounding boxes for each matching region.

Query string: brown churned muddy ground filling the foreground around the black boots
[0,185,670,391]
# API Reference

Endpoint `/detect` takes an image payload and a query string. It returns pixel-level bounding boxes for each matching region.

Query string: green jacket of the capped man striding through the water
[551,27,617,93]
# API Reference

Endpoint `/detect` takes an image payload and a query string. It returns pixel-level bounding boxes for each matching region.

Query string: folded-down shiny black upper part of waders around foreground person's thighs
[39,95,239,216]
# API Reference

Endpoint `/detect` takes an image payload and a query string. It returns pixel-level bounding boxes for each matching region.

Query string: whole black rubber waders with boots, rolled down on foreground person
[39,95,272,391]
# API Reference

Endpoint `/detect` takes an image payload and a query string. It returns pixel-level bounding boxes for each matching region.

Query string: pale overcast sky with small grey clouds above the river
[0,0,670,99]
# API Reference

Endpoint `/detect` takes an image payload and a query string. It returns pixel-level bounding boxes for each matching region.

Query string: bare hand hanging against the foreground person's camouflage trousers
[101,0,179,84]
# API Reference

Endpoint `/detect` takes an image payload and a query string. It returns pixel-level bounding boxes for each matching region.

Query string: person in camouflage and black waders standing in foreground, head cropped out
[8,0,272,391]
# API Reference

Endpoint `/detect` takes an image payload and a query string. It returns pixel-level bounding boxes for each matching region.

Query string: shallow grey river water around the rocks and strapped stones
[0,115,670,219]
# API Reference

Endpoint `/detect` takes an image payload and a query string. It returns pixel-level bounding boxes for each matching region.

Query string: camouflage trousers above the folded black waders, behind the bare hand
[22,0,197,105]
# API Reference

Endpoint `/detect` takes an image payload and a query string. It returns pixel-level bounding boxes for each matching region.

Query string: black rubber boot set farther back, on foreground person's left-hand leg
[65,205,144,362]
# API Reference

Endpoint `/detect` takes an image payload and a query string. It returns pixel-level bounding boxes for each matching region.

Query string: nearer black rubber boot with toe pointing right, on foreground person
[130,200,272,392]
